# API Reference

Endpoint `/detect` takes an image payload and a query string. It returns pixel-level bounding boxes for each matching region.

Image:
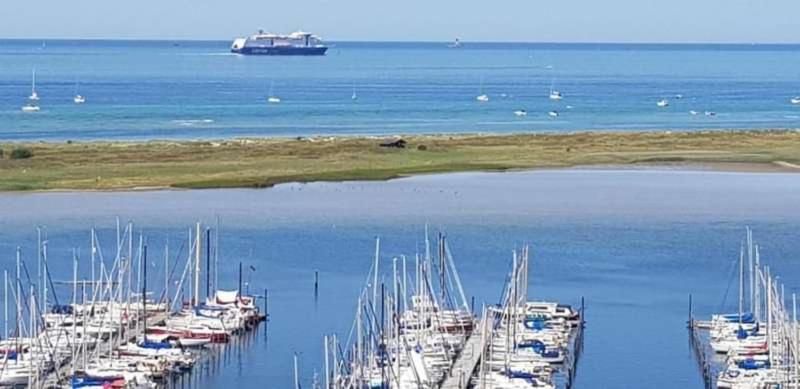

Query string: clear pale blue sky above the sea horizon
[0,0,800,43]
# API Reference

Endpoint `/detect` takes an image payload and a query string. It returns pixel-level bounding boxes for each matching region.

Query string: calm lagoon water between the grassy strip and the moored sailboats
[0,169,800,388]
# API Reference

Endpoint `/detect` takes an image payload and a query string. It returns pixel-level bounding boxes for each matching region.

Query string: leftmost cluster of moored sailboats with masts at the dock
[0,219,266,388]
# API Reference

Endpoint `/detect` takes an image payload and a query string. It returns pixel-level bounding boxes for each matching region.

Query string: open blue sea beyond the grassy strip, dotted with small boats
[0,40,800,141]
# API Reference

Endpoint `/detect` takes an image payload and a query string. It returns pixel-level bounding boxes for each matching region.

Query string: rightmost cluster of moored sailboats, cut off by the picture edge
[688,228,800,389]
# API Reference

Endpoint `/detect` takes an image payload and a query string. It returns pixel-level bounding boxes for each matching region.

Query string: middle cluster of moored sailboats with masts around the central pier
[324,232,584,389]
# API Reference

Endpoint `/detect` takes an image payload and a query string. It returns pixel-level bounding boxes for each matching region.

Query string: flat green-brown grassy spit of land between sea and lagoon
[0,131,800,191]
